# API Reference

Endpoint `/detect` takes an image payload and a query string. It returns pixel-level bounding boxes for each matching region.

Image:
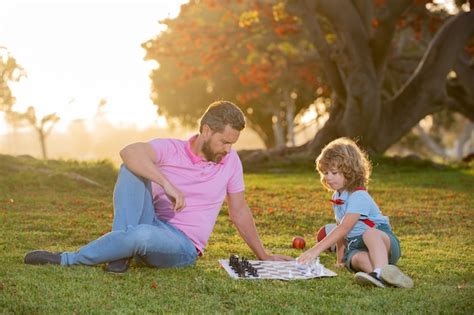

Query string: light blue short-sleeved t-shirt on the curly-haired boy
[332,190,389,238]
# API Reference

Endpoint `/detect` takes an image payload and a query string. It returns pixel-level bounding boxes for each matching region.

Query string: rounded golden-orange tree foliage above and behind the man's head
[143,0,321,148]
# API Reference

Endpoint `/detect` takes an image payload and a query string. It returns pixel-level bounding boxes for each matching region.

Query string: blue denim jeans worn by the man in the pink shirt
[61,165,198,268]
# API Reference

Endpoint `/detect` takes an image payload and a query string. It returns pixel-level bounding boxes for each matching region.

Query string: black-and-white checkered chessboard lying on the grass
[219,259,337,280]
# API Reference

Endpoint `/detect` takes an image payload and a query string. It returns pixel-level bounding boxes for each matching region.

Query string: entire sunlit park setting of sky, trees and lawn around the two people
[0,0,474,314]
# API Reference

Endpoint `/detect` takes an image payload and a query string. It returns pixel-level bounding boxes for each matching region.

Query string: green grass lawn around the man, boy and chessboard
[0,155,474,314]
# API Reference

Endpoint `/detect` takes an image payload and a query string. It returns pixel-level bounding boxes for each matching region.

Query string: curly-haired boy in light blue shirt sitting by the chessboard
[298,138,413,288]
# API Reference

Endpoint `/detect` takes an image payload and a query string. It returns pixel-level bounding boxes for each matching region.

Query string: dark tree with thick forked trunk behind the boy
[291,0,474,155]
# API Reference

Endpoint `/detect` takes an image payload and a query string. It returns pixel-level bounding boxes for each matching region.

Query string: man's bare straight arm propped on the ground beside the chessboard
[227,192,293,260]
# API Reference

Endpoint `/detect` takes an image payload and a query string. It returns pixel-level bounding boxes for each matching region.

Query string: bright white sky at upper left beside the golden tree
[0,0,187,134]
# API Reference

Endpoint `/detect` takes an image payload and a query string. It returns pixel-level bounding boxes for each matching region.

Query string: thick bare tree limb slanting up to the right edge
[377,11,474,152]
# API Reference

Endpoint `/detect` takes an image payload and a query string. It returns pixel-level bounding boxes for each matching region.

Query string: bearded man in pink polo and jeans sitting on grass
[25,101,292,273]
